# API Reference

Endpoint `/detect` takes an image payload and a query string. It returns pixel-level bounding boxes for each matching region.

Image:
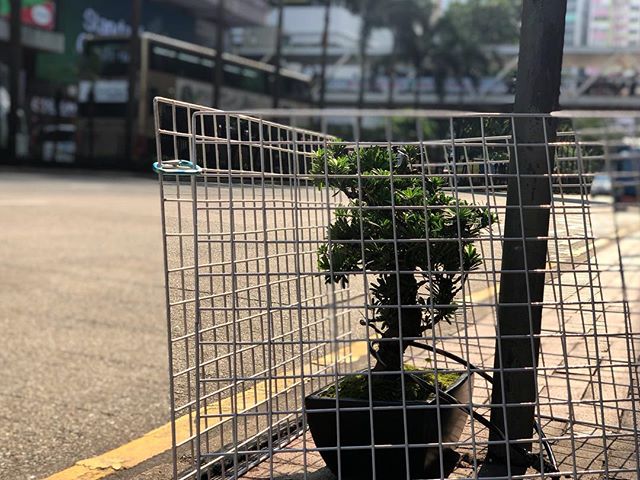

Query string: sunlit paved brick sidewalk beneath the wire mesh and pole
[94,218,640,480]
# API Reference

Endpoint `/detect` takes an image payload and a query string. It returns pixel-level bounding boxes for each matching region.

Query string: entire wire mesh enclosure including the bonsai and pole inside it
[156,99,640,479]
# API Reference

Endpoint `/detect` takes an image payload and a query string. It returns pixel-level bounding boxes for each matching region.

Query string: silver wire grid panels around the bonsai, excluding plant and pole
[156,99,640,479]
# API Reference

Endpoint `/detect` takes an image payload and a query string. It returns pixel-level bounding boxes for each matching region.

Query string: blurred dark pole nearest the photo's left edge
[8,0,22,160]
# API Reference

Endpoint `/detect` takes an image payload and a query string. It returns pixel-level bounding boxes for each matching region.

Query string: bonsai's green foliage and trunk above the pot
[311,144,495,372]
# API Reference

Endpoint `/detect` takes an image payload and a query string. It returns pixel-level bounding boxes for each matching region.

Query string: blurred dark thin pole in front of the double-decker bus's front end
[124,0,142,163]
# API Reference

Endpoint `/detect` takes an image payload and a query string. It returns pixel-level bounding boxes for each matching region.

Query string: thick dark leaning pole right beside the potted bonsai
[481,0,567,476]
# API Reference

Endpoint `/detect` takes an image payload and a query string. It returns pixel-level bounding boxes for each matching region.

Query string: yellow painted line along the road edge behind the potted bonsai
[45,287,494,480]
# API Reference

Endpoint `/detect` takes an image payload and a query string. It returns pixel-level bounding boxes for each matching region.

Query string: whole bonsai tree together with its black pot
[305,144,495,480]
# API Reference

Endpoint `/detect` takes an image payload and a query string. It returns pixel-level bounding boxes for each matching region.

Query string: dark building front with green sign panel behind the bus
[0,0,270,163]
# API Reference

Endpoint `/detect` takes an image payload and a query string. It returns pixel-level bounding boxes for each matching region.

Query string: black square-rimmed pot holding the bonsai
[305,373,473,480]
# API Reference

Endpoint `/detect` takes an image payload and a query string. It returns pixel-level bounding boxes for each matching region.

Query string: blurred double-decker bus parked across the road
[77,33,311,166]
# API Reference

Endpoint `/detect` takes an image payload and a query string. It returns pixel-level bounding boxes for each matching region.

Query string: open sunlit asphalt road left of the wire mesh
[0,170,168,480]
